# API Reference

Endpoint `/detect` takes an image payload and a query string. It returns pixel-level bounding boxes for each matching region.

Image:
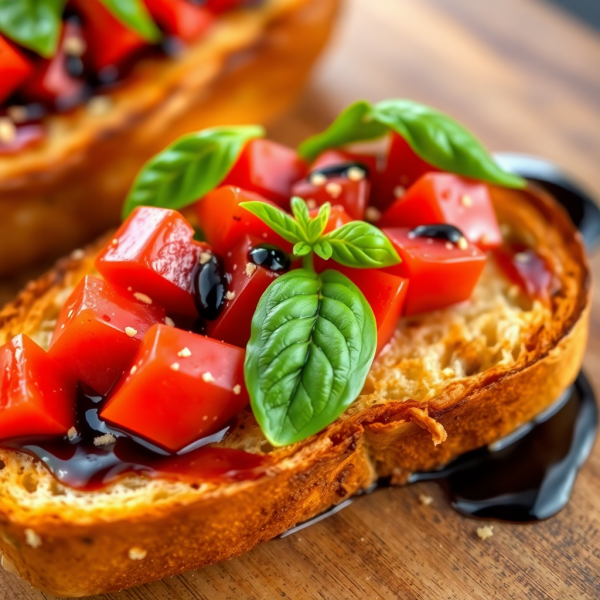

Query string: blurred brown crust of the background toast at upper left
[0,0,340,276]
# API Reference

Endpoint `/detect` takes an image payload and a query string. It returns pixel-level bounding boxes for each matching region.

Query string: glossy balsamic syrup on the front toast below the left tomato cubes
[3,387,270,491]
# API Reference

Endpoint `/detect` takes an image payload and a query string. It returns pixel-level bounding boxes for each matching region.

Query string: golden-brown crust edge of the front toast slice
[0,187,590,597]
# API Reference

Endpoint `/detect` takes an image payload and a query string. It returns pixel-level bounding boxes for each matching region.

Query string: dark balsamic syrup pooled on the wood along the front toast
[280,372,598,537]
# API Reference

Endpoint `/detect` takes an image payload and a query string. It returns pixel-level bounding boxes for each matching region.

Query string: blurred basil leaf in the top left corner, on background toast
[0,0,66,58]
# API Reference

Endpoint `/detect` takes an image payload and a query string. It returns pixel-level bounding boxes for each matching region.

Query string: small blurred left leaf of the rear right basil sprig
[298,100,388,162]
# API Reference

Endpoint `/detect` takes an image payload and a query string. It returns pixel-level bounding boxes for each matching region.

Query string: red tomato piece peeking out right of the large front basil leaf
[335,265,409,356]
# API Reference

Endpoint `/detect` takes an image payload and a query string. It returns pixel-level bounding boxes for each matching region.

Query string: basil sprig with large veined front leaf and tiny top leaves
[240,198,400,446]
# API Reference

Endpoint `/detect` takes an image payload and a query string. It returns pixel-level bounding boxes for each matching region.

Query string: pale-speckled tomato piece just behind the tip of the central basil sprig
[292,177,371,221]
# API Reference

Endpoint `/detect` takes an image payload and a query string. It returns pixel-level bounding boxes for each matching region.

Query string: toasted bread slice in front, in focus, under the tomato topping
[0,187,589,596]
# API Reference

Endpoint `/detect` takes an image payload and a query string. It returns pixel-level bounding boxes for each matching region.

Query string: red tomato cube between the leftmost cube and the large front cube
[49,275,165,395]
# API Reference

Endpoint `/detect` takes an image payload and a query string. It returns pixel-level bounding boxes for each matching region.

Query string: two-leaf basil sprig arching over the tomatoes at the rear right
[299,99,526,188]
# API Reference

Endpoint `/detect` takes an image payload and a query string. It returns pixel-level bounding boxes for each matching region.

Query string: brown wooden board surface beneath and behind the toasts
[0,0,600,600]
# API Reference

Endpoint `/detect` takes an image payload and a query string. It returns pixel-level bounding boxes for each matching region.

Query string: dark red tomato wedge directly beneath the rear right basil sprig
[371,133,438,211]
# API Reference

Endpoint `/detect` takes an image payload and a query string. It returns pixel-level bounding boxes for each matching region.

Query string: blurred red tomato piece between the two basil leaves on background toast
[71,0,148,71]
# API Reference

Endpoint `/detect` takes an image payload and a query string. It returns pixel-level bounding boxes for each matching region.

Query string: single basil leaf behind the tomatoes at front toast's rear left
[123,125,264,218]
